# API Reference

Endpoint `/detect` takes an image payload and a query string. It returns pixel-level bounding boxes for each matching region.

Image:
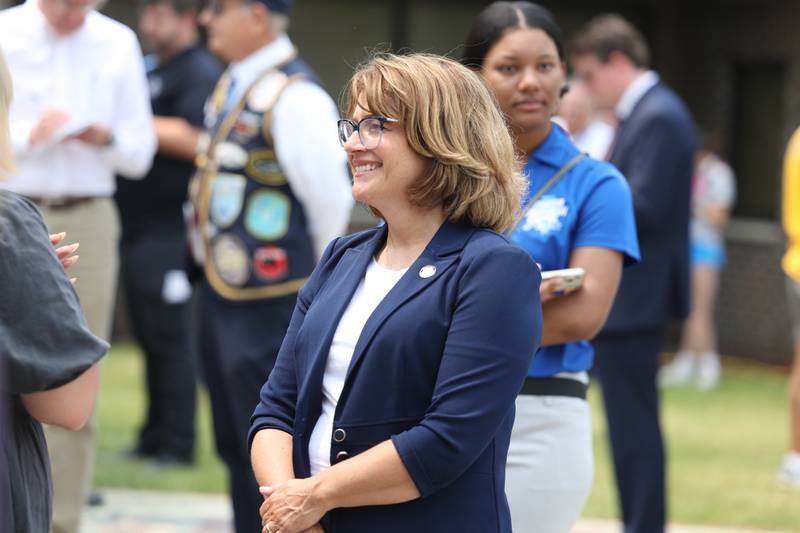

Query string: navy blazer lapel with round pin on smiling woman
[339,222,474,390]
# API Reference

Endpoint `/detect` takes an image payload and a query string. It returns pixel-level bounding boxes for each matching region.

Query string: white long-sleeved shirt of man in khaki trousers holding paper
[0,0,156,197]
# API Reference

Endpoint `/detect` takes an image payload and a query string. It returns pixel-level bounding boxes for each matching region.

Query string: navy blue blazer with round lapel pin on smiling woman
[249,222,542,533]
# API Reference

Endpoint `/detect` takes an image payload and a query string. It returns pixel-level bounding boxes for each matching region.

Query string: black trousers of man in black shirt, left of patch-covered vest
[120,229,197,461]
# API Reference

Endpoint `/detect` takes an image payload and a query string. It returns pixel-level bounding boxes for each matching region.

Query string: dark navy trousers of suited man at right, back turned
[592,331,666,533]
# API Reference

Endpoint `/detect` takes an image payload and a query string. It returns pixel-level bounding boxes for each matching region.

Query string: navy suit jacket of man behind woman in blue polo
[603,83,695,333]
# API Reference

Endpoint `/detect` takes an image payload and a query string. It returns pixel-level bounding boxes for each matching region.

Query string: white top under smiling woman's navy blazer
[308,259,408,475]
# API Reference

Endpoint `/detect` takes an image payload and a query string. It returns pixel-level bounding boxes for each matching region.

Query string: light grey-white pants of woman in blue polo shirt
[506,395,594,533]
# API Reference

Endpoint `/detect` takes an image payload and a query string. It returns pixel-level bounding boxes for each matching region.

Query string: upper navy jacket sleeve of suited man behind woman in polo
[625,113,694,234]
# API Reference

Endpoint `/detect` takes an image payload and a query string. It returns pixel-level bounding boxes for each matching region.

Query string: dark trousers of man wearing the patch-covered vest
[199,283,296,533]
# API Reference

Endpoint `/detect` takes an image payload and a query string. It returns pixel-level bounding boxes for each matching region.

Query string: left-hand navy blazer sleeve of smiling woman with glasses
[247,239,338,449]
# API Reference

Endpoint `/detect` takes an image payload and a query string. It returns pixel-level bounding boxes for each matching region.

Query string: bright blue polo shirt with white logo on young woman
[511,124,639,377]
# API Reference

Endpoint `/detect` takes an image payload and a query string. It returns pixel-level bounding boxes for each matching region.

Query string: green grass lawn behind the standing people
[95,344,800,531]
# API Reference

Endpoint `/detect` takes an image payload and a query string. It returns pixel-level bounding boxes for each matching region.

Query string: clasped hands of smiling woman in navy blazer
[259,478,328,533]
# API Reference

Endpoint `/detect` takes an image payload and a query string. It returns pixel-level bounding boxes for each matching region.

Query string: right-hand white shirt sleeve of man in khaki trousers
[104,33,158,179]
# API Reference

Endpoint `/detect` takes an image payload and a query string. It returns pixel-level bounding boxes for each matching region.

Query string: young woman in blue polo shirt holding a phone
[463,2,639,533]
